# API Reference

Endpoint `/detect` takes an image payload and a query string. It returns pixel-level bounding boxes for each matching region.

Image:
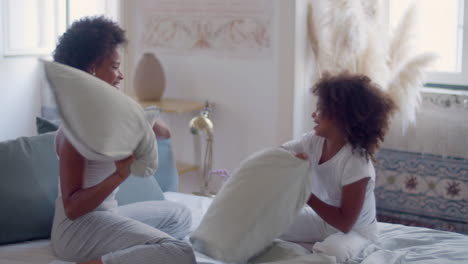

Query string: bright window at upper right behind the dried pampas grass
[388,0,468,89]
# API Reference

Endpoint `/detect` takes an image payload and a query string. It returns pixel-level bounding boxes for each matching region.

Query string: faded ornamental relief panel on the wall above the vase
[137,0,273,57]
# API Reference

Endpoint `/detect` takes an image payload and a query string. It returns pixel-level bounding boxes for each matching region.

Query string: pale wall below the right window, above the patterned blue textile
[384,88,468,159]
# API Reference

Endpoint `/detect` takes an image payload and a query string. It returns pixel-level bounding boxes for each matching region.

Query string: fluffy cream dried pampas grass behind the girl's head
[308,0,435,128]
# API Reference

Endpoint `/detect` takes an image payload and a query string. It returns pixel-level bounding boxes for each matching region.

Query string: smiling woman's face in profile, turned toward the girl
[91,49,123,89]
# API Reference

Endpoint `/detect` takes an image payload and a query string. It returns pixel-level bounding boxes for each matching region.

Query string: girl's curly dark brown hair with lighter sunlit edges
[312,72,396,161]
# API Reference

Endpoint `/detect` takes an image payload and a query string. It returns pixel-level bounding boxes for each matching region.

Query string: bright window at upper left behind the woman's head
[0,0,119,56]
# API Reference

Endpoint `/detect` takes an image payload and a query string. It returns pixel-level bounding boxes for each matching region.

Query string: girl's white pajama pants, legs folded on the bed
[280,206,378,263]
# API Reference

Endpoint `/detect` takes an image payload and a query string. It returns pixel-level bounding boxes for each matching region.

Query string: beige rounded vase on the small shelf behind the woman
[133,53,166,101]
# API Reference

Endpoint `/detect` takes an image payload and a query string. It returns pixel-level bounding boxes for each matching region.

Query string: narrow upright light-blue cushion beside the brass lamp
[154,138,179,192]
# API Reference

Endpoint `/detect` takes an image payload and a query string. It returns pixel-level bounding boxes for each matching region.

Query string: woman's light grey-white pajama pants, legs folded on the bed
[51,197,195,264]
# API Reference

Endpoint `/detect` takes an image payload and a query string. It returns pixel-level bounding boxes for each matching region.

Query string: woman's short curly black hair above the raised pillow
[54,16,127,71]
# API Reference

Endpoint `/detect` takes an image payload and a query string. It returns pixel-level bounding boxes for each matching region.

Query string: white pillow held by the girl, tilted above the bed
[190,148,311,263]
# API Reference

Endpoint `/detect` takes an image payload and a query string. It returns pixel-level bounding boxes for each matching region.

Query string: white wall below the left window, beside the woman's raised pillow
[0,5,41,141]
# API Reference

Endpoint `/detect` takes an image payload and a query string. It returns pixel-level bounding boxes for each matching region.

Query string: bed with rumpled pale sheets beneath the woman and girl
[0,192,468,264]
